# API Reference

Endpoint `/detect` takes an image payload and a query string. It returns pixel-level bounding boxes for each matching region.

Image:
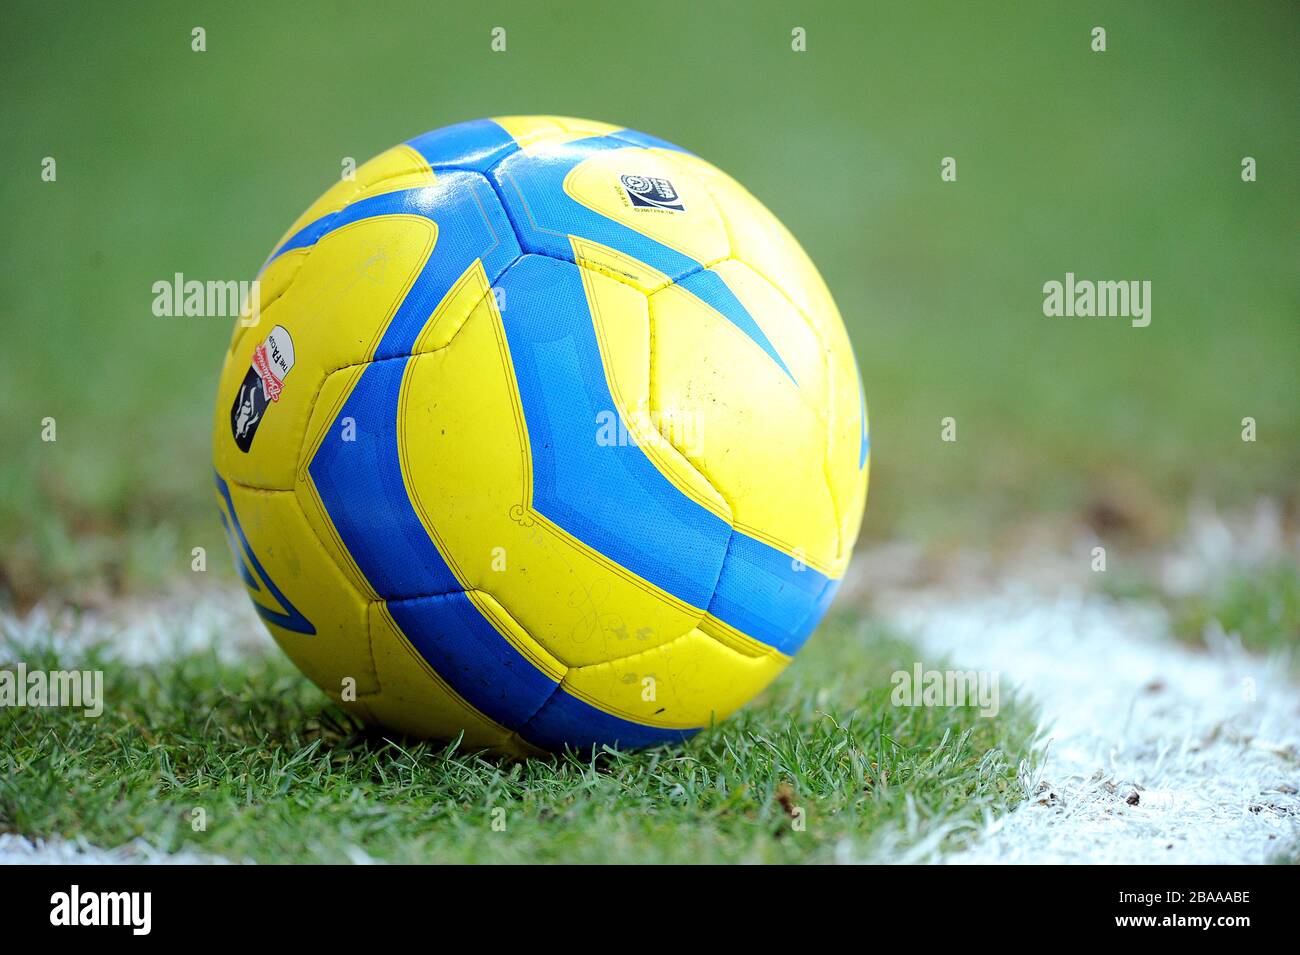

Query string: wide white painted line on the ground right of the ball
[888,590,1300,863]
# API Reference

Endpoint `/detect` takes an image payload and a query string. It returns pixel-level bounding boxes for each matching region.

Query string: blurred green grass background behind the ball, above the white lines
[0,0,1300,603]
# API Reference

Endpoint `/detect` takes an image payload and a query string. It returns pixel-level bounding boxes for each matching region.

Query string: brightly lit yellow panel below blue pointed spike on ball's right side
[650,285,842,576]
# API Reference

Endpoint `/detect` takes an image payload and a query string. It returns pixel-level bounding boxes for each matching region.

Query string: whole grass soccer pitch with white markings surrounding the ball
[0,3,1300,863]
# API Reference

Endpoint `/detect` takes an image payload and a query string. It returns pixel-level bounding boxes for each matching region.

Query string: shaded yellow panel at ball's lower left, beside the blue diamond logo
[217,483,378,700]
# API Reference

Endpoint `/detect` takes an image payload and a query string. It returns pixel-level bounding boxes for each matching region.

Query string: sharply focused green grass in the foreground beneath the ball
[0,617,1036,863]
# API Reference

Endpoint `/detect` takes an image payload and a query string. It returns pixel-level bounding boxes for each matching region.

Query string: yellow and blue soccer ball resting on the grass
[215,116,868,754]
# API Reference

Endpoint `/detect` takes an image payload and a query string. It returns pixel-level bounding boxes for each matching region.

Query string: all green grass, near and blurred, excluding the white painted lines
[0,0,1300,861]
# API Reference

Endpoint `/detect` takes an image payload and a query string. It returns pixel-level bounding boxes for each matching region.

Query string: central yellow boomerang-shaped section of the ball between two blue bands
[398,273,701,665]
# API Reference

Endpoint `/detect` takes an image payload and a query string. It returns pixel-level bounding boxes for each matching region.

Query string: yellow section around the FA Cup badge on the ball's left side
[213,216,437,489]
